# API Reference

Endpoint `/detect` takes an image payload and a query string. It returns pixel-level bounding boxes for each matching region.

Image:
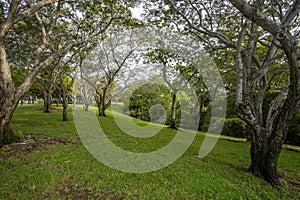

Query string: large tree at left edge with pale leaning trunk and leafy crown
[0,0,124,146]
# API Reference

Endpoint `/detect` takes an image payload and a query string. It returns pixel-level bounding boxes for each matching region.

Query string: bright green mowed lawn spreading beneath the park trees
[0,105,300,199]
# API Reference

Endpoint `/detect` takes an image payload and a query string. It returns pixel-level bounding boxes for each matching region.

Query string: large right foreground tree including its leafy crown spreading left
[146,0,300,184]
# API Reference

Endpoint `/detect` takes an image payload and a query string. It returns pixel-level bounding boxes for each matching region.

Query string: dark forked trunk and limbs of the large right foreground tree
[230,0,300,184]
